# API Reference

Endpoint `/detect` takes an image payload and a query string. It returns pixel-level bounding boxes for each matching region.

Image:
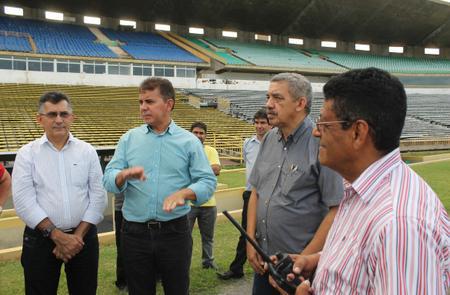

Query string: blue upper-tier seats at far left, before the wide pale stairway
[0,17,117,58]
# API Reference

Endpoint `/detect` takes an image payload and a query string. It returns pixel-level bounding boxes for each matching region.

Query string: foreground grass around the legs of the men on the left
[0,220,252,295]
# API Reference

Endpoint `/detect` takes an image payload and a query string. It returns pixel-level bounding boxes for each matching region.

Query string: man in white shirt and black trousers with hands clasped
[12,92,107,294]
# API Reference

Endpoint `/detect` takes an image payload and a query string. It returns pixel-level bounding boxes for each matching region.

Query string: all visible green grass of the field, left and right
[0,160,450,295]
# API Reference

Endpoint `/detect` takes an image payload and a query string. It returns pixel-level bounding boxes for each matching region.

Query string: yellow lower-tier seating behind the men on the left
[0,84,254,154]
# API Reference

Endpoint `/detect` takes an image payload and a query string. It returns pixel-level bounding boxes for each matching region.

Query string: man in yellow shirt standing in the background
[188,122,221,270]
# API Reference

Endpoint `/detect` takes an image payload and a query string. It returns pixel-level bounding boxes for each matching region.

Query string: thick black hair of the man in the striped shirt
[323,68,407,154]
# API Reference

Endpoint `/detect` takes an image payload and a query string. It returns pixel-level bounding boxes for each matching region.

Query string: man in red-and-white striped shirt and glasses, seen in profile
[276,68,450,294]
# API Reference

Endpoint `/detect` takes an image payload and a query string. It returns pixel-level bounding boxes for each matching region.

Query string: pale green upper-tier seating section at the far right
[307,49,450,74]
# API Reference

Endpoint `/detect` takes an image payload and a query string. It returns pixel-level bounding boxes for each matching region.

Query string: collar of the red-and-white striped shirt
[344,148,402,202]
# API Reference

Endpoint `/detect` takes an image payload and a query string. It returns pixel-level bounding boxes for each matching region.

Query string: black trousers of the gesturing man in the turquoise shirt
[122,216,192,295]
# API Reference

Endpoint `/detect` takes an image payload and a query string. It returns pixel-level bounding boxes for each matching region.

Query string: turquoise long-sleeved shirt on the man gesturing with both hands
[103,121,217,222]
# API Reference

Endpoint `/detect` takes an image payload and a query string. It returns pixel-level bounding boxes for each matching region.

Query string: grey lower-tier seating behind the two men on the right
[185,89,450,139]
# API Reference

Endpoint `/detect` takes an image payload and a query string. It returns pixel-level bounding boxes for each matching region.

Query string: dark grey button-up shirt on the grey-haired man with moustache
[250,116,343,254]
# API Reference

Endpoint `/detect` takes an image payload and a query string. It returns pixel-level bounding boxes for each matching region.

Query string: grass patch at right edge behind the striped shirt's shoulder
[411,161,450,212]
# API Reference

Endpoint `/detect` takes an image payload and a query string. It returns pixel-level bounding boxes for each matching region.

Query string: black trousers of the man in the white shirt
[21,226,99,295]
